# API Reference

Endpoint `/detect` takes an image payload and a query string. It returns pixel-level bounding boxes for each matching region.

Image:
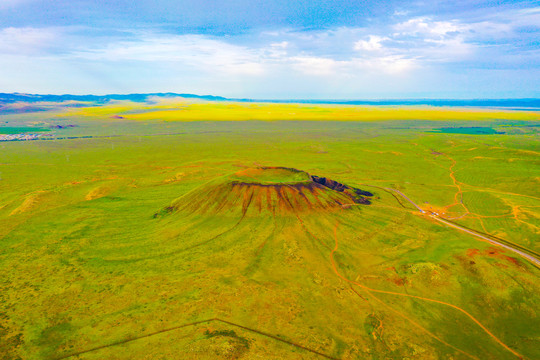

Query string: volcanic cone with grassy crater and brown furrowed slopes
[165,167,373,216]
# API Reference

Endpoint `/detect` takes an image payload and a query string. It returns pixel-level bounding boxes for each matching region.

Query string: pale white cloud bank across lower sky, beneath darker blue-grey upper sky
[0,1,540,99]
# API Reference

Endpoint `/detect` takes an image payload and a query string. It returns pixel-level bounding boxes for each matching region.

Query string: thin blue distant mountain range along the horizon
[0,93,540,109]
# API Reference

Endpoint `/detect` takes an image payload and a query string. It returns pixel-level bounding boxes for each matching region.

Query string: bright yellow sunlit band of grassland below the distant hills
[64,101,538,121]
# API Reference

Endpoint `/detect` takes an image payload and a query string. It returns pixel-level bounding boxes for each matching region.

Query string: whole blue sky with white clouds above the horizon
[0,0,540,99]
